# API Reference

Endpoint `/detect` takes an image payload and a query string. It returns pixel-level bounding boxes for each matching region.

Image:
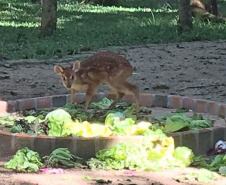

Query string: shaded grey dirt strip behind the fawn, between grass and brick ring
[0,40,226,103]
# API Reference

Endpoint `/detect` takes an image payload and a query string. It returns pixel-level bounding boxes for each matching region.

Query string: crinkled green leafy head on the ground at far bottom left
[4,147,43,172]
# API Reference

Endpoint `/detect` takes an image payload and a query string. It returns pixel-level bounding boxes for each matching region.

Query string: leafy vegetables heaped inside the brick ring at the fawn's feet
[0,98,213,137]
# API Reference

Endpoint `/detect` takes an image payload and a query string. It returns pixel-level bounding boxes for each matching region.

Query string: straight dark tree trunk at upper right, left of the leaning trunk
[178,0,192,31]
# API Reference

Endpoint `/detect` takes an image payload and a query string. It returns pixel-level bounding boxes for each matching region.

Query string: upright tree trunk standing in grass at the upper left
[40,0,57,37]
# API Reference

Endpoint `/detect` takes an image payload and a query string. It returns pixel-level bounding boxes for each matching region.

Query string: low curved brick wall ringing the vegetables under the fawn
[0,93,226,158]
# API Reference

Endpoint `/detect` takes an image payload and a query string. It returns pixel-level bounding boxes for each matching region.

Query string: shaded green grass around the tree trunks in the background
[0,0,226,59]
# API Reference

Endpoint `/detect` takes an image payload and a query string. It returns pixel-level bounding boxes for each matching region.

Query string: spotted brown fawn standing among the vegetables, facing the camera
[54,52,140,115]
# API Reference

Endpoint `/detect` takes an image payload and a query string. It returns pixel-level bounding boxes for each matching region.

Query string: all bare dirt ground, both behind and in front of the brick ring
[0,41,226,185]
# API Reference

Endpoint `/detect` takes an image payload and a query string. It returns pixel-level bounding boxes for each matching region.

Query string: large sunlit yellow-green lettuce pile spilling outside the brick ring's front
[88,129,194,171]
